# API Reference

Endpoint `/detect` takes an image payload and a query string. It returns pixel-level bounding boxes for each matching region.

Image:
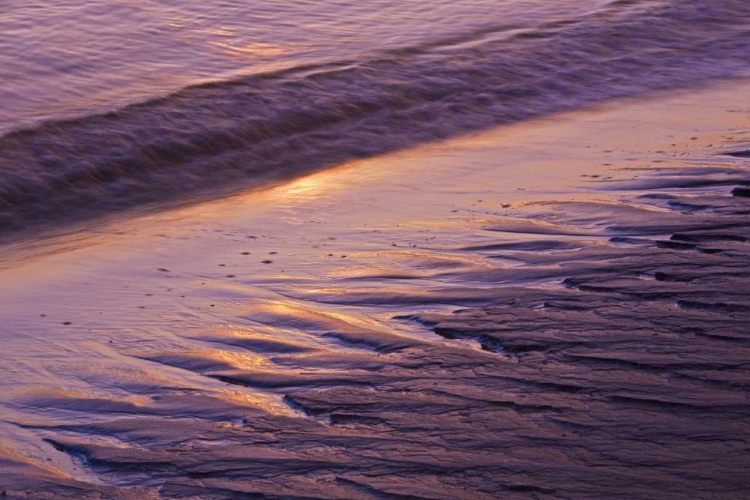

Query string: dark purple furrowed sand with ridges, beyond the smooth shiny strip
[5,122,750,499]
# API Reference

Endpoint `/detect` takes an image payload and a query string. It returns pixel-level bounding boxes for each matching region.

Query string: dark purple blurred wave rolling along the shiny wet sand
[0,0,750,232]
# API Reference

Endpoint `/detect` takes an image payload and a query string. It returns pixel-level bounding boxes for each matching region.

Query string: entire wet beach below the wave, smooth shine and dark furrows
[0,82,750,499]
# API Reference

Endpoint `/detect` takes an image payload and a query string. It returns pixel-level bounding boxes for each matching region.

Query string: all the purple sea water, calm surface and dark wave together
[0,0,750,230]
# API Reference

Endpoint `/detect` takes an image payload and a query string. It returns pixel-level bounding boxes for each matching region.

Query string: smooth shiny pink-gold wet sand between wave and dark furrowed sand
[0,80,747,490]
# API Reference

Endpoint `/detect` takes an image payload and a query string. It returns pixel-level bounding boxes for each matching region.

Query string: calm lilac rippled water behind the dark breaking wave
[0,0,603,131]
